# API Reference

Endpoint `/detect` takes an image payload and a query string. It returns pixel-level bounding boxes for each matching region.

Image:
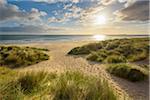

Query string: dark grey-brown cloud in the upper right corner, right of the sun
[115,1,149,21]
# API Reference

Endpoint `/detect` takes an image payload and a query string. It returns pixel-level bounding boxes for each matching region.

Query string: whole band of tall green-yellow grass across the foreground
[0,68,117,100]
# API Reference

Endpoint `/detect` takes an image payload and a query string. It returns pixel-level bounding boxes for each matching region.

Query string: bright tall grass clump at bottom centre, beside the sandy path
[49,72,117,100]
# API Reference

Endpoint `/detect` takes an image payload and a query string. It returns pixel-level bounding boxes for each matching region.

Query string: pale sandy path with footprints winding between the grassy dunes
[16,42,149,100]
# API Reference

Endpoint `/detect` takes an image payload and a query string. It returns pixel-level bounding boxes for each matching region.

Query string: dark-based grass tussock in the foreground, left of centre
[17,72,48,94]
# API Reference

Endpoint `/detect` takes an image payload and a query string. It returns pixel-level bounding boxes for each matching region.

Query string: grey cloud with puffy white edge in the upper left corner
[0,0,47,21]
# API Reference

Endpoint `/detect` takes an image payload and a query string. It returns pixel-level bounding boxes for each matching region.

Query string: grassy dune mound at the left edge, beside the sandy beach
[0,46,49,68]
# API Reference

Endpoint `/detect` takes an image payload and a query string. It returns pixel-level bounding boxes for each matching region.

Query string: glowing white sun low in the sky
[94,15,107,25]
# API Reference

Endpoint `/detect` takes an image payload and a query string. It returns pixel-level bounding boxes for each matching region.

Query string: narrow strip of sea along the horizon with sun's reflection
[0,35,149,44]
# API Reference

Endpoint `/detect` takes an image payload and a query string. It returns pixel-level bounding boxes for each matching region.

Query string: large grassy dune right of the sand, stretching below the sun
[68,38,149,63]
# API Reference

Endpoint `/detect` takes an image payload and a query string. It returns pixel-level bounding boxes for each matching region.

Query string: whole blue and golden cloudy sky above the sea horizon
[0,0,149,35]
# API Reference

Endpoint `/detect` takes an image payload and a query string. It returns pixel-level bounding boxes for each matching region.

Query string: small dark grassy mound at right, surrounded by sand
[107,64,148,82]
